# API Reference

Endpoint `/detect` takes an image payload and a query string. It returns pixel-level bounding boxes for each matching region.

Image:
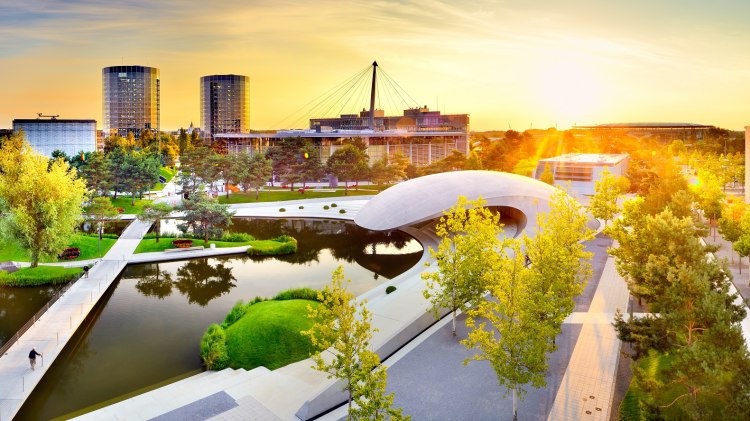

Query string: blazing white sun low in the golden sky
[534,57,601,125]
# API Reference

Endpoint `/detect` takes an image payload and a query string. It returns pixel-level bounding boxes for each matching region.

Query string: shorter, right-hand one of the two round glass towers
[201,75,250,138]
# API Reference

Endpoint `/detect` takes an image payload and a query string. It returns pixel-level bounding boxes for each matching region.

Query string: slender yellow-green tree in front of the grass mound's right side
[302,266,408,419]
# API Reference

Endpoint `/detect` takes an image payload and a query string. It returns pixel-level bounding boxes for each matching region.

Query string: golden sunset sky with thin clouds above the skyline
[0,0,750,130]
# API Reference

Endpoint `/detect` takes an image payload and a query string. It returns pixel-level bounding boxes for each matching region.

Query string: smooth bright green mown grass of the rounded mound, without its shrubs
[220,300,320,370]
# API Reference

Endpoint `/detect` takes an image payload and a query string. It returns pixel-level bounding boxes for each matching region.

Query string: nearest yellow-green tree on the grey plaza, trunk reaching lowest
[462,240,553,420]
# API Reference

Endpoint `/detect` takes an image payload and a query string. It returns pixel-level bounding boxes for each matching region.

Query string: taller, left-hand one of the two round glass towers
[102,66,160,138]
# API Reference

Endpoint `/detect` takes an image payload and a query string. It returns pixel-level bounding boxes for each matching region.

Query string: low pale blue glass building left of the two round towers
[13,119,96,157]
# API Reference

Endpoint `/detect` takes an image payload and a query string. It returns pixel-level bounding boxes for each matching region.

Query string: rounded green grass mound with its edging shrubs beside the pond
[201,288,320,370]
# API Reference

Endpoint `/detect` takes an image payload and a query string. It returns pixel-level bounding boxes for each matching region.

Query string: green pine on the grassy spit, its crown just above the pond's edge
[176,191,234,244]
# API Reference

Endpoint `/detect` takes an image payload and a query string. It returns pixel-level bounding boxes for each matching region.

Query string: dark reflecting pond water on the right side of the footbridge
[18,219,422,419]
